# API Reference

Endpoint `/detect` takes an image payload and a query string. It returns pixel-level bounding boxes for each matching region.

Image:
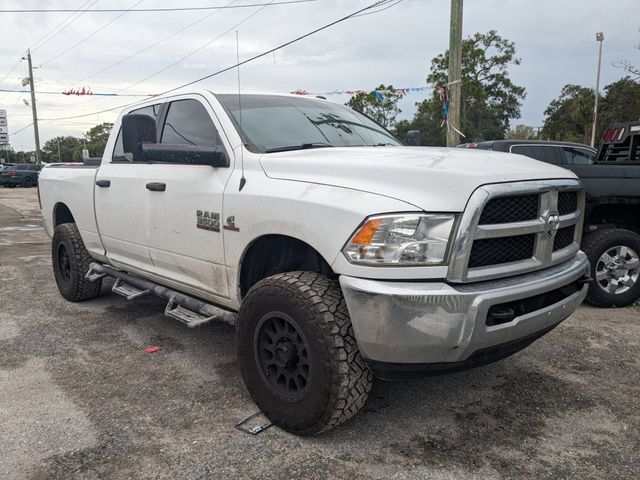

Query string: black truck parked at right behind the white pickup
[459,133,640,307]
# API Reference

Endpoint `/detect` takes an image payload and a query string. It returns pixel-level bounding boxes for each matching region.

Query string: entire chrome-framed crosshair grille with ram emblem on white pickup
[447,180,584,282]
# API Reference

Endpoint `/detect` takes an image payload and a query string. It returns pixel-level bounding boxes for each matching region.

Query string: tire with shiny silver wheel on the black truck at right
[582,228,640,307]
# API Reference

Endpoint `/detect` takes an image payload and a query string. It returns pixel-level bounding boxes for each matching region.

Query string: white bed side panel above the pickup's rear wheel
[39,166,105,260]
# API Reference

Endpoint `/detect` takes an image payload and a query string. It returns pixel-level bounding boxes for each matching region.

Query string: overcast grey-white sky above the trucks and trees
[0,0,640,150]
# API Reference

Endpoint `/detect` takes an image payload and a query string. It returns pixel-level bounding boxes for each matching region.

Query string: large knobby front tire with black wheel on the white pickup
[236,272,373,435]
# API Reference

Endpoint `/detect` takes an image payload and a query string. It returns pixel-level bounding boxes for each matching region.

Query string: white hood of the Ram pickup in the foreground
[260,147,576,212]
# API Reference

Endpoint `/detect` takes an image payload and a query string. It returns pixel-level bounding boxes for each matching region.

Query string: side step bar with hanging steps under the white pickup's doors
[85,262,237,327]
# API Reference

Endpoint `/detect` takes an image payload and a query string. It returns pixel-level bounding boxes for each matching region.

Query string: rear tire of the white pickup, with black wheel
[51,223,102,302]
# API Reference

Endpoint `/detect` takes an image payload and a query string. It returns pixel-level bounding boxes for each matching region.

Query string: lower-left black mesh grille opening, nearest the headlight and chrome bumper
[469,234,536,268]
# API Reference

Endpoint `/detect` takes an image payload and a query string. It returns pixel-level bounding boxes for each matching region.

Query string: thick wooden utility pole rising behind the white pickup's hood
[447,0,462,147]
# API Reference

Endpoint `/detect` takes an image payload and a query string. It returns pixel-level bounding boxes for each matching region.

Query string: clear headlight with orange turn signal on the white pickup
[342,213,455,266]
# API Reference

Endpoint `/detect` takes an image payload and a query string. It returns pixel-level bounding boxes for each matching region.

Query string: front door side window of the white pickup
[160,100,222,147]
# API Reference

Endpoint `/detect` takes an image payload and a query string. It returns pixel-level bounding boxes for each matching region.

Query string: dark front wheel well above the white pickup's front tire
[240,235,334,297]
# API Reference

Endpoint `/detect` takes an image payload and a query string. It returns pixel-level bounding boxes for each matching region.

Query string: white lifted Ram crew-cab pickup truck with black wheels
[39,91,589,435]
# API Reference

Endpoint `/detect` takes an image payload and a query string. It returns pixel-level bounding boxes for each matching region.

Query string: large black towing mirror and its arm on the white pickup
[122,113,229,167]
